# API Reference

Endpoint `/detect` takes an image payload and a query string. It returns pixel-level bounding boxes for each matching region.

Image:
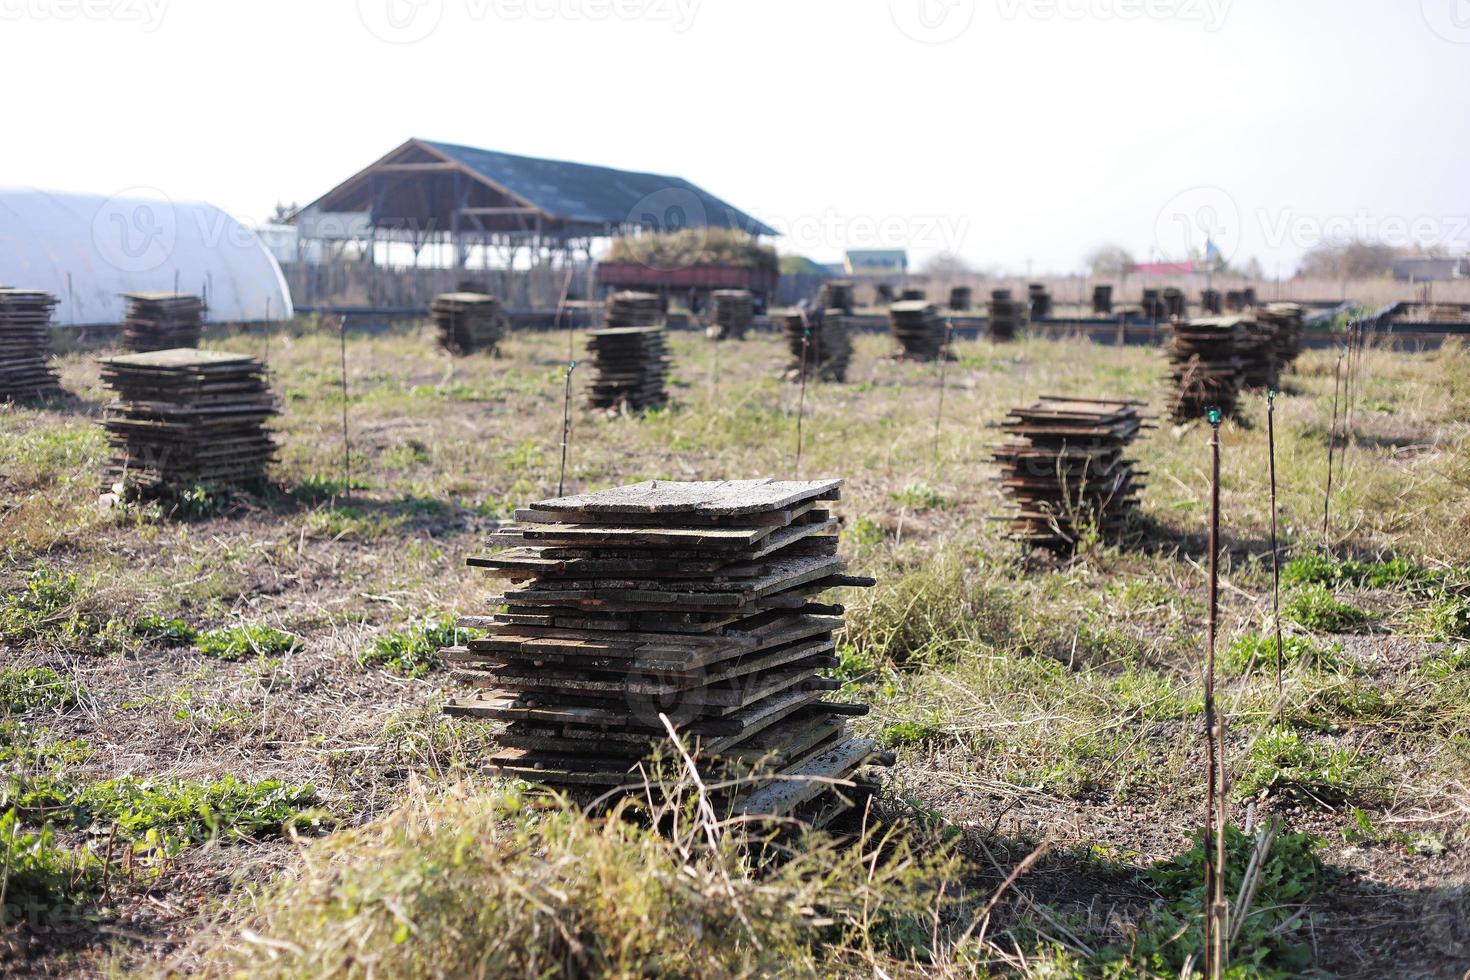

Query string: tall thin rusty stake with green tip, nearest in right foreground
[1200,408,1226,979]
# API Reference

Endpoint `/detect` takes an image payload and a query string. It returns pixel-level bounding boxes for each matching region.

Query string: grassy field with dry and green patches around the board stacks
[0,322,1470,977]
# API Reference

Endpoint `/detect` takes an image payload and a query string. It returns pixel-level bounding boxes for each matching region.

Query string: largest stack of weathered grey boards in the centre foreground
[442,480,878,824]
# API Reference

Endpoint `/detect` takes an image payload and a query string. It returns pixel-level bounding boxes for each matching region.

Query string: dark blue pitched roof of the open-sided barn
[303,140,776,237]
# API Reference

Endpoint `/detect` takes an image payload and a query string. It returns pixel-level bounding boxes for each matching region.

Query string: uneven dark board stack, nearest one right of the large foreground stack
[995,395,1145,550]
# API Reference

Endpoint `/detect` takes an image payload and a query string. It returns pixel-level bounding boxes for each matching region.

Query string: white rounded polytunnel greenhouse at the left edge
[0,188,291,326]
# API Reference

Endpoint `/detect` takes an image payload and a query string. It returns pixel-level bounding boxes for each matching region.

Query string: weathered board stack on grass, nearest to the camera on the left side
[101,348,276,497]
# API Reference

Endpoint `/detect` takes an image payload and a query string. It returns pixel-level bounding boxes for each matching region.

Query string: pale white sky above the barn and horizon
[0,0,1470,275]
